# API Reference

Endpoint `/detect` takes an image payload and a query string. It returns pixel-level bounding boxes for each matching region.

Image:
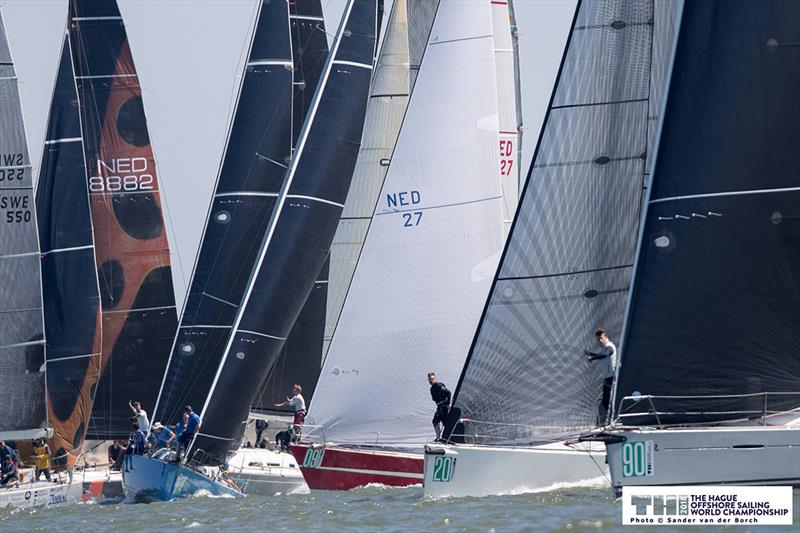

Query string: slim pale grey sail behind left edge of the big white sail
[320,0,439,362]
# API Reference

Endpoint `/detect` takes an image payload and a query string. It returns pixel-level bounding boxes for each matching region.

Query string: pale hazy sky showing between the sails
[0,0,575,305]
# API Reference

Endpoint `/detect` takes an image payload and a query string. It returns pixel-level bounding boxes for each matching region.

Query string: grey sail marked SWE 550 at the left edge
[0,9,47,440]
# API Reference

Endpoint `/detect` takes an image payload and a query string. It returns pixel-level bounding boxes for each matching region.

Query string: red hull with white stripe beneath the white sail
[291,444,423,490]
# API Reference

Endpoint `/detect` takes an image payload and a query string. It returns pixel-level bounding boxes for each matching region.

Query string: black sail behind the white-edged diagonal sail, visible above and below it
[253,0,328,409]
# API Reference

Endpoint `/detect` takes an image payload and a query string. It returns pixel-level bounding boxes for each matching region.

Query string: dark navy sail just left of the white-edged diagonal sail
[153,0,310,430]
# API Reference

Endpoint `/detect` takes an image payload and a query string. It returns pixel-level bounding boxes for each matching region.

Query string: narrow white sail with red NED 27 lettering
[491,0,522,235]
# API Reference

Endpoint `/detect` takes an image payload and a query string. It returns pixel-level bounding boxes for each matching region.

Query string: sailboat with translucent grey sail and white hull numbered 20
[424,0,674,497]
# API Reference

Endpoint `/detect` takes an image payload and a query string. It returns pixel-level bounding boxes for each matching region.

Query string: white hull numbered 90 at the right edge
[605,426,800,492]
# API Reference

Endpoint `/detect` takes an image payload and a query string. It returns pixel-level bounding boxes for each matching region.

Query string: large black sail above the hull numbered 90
[615,0,800,424]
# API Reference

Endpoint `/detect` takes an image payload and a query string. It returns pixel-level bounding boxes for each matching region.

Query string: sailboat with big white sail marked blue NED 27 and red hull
[292,0,513,489]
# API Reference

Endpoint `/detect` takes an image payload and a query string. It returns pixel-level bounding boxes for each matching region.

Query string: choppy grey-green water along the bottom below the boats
[0,487,800,533]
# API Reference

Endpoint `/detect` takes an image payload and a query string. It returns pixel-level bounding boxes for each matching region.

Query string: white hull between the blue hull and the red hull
[228,448,309,496]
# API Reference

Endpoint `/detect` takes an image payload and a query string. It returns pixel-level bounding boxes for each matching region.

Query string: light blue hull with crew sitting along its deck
[122,455,244,501]
